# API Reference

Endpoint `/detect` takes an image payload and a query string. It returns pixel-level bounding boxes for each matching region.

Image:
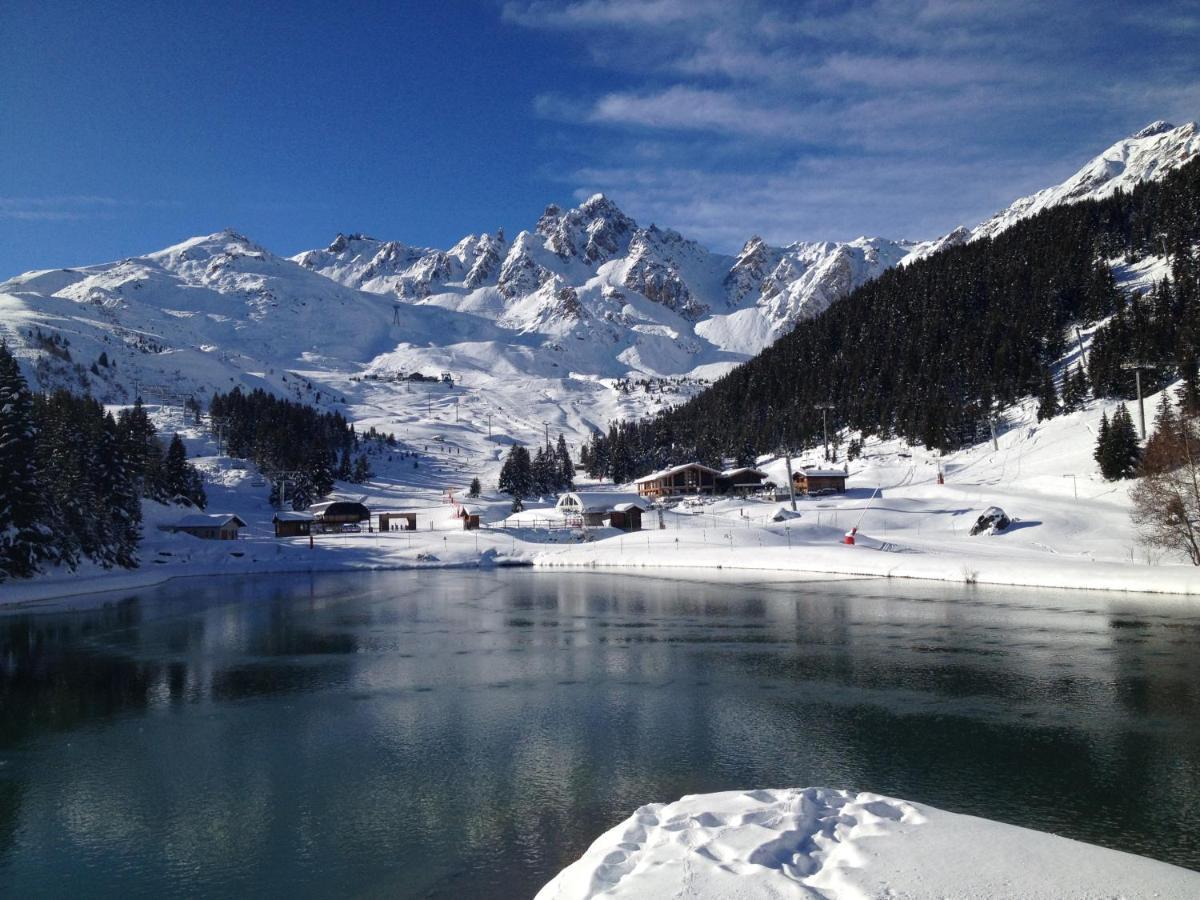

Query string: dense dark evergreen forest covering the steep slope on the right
[589,153,1200,474]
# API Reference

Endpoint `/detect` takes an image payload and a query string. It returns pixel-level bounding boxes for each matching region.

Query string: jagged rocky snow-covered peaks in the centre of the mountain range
[293,194,918,355]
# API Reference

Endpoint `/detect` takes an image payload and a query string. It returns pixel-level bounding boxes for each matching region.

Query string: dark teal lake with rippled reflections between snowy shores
[0,569,1200,898]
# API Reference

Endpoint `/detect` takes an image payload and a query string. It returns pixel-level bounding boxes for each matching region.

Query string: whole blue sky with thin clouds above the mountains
[0,0,1200,276]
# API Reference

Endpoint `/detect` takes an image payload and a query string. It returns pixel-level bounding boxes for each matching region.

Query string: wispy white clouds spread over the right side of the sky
[505,0,1200,248]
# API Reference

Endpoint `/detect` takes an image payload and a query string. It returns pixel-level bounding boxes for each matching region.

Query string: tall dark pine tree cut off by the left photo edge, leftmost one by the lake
[0,343,50,580]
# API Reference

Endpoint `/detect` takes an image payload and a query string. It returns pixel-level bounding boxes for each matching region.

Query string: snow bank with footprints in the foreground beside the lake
[538,787,1200,900]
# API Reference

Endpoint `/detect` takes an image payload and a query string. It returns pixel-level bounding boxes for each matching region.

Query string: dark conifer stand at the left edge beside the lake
[0,343,205,578]
